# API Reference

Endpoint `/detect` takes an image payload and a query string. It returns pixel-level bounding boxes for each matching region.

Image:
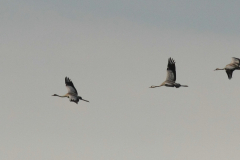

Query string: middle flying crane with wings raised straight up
[150,57,188,88]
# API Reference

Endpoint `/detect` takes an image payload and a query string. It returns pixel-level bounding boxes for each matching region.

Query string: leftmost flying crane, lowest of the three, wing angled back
[52,77,89,104]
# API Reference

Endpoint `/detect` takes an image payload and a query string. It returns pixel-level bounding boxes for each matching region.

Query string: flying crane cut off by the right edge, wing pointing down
[215,57,240,79]
